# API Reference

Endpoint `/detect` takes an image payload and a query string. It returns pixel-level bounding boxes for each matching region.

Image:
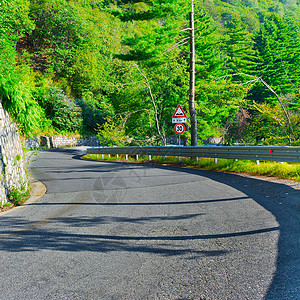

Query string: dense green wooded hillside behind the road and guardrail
[0,0,300,145]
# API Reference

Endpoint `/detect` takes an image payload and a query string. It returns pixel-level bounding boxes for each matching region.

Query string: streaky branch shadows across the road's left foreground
[0,214,228,259]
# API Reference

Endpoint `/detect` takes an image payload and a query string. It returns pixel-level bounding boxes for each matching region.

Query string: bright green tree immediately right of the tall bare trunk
[190,6,250,140]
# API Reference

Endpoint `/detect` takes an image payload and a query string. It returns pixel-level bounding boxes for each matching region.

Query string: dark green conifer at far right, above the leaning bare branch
[253,14,300,102]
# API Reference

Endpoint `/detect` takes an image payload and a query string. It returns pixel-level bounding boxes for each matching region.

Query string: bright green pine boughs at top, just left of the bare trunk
[111,0,189,64]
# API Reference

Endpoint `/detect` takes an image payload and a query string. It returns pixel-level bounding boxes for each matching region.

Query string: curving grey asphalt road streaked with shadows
[0,148,300,300]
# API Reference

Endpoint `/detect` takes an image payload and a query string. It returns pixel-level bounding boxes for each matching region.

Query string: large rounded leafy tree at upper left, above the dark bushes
[29,0,121,97]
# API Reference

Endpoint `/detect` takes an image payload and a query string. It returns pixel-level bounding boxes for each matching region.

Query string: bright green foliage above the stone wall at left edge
[0,0,43,131]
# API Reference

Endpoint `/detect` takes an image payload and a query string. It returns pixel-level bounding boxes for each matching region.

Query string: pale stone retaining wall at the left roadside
[0,103,28,204]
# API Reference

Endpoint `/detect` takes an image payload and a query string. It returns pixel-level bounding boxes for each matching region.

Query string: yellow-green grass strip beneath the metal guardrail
[83,154,300,182]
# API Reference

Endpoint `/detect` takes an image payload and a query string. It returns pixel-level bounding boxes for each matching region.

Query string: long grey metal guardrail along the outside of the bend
[87,146,300,162]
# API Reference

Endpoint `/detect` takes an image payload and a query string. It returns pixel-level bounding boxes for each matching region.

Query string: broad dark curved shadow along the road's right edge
[155,167,300,299]
